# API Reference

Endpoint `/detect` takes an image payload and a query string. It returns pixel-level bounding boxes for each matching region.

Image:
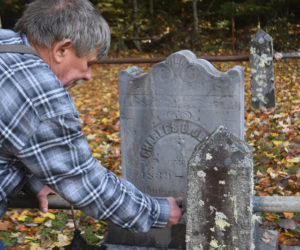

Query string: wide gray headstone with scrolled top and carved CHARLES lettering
[106,50,244,249]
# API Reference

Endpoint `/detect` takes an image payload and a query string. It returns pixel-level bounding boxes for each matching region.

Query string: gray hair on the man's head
[15,0,110,60]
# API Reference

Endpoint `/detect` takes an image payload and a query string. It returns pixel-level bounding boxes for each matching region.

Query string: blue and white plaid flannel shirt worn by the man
[0,29,170,231]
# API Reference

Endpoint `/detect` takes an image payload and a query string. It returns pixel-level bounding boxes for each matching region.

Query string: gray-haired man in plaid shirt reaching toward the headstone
[0,0,181,240]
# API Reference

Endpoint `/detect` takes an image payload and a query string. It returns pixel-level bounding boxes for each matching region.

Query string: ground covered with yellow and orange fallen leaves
[0,50,300,249]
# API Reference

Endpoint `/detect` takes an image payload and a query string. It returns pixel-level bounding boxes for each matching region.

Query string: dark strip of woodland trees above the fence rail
[0,0,300,53]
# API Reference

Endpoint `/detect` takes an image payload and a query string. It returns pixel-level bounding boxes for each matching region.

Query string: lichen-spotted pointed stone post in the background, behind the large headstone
[250,30,275,109]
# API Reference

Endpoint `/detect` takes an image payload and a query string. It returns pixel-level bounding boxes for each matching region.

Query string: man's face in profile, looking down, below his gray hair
[51,48,97,89]
